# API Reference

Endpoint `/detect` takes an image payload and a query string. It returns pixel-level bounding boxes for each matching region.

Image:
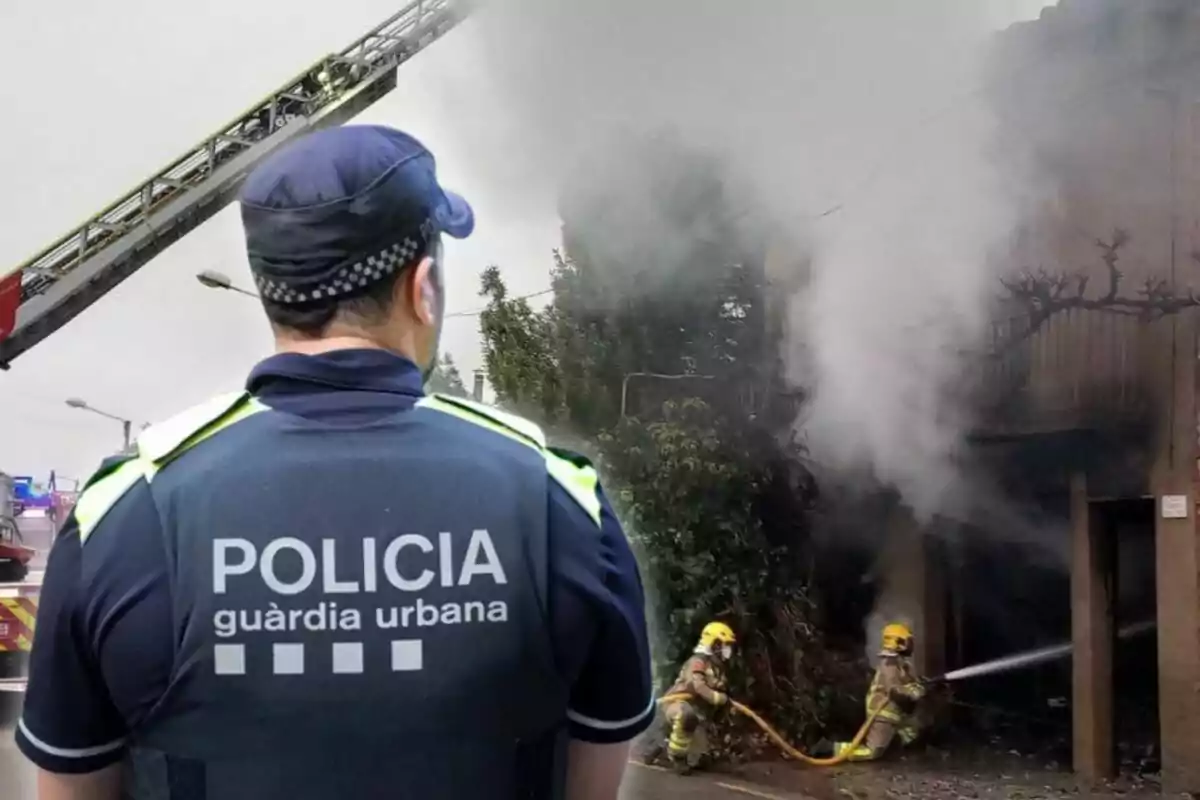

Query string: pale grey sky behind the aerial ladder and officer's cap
[0,0,1044,479]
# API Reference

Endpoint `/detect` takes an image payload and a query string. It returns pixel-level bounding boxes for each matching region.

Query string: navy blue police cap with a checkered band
[241,125,475,305]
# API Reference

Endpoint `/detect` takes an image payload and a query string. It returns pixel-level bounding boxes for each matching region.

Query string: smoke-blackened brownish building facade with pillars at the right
[892,0,1200,792]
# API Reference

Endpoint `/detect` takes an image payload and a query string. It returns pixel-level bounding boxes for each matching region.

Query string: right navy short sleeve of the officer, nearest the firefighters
[550,465,655,744]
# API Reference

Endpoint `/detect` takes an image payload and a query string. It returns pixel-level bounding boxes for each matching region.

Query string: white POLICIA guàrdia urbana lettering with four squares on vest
[212,529,509,675]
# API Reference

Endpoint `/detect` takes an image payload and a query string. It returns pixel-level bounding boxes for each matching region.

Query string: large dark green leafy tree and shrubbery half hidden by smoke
[480,136,860,743]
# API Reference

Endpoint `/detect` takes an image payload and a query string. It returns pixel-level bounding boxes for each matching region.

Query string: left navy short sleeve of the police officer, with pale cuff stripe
[16,472,173,774]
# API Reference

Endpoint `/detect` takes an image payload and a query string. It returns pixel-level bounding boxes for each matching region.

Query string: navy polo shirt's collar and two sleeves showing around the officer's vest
[17,349,654,772]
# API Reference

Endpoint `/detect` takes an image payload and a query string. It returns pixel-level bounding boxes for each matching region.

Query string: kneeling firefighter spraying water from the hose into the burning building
[815,622,925,762]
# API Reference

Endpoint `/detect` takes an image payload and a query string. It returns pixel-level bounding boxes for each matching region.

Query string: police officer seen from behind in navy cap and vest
[17,126,654,800]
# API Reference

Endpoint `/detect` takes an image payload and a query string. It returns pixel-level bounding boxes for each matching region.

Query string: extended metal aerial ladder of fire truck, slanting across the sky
[0,0,468,369]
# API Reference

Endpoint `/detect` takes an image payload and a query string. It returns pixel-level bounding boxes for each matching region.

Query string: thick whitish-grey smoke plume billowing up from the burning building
[458,0,1032,513]
